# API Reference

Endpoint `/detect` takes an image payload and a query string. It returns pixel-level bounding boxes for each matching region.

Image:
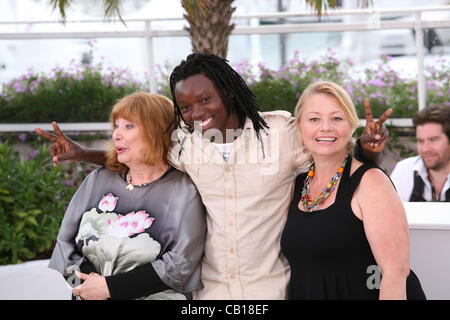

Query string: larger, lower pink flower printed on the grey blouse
[108,210,155,238]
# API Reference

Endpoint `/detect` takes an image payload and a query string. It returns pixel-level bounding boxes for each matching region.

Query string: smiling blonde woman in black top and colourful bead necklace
[281,82,425,299]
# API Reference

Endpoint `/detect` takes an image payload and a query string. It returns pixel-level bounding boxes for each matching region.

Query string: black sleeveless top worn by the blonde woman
[281,157,425,300]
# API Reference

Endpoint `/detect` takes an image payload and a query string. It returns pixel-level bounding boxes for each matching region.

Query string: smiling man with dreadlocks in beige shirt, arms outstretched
[37,54,389,299]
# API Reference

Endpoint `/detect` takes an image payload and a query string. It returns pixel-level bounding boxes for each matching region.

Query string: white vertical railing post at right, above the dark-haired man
[414,11,426,110]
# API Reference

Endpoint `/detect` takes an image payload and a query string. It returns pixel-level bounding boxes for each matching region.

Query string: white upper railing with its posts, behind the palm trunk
[0,6,450,131]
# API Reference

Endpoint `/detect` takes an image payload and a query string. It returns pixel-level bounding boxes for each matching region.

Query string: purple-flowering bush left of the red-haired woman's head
[0,63,143,123]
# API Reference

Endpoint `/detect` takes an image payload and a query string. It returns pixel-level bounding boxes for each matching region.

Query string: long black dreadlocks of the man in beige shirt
[170,53,269,137]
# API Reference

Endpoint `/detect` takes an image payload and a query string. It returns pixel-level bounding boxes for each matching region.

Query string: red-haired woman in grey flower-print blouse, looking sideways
[44,92,206,300]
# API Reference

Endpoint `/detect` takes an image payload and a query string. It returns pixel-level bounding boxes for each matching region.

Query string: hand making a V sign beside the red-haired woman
[34,122,84,166]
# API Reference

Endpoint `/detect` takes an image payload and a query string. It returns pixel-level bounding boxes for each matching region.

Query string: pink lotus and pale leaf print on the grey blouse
[75,193,185,299]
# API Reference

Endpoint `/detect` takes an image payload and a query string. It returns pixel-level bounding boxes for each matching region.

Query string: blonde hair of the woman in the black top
[295,81,359,153]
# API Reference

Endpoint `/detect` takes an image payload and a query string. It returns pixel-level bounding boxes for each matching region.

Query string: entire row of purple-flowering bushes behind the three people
[0,51,450,123]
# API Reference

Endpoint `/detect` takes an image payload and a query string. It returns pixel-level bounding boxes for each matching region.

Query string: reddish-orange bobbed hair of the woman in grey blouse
[105,91,175,171]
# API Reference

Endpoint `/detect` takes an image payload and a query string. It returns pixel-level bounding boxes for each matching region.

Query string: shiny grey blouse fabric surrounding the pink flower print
[49,167,206,293]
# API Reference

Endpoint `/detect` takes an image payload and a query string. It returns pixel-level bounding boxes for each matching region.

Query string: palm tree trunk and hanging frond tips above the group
[49,0,372,57]
